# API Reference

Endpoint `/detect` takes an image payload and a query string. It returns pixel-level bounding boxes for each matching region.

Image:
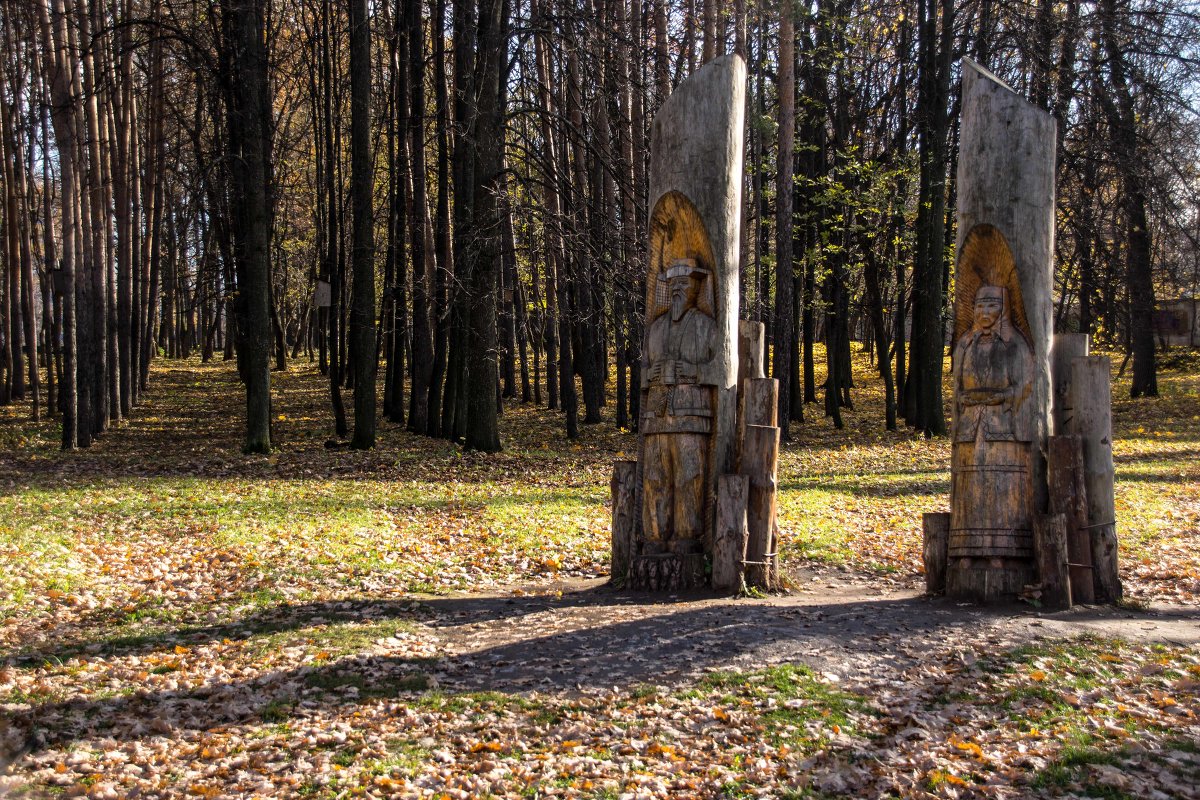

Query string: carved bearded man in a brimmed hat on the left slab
[641,258,718,553]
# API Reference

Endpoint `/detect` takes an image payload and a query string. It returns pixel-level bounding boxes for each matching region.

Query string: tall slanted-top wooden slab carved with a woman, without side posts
[946,60,1055,602]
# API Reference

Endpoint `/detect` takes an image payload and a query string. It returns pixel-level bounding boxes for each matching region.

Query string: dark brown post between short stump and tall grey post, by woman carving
[1046,435,1096,603]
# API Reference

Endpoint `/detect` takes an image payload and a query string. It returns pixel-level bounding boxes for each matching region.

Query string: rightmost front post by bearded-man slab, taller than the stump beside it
[742,425,779,591]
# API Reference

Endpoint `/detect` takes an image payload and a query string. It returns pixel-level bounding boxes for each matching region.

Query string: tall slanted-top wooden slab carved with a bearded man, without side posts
[632,55,745,575]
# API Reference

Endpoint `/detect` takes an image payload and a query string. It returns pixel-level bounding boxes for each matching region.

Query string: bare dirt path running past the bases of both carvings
[422,575,1200,691]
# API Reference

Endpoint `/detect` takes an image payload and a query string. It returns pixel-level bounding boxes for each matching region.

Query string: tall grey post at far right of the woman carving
[1070,355,1122,603]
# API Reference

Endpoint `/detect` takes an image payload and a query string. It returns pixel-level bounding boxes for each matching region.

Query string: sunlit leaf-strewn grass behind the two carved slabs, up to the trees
[0,348,1200,621]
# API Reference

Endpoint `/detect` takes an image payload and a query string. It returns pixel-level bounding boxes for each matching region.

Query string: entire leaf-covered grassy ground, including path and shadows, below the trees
[0,345,1200,798]
